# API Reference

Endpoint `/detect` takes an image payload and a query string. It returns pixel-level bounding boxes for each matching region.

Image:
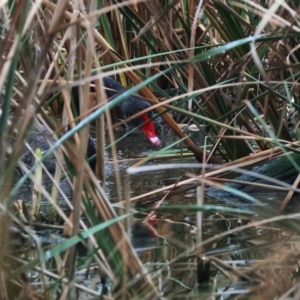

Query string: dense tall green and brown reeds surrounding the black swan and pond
[0,0,300,299]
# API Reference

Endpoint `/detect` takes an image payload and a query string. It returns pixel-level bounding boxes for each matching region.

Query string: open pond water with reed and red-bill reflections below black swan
[13,127,300,299]
